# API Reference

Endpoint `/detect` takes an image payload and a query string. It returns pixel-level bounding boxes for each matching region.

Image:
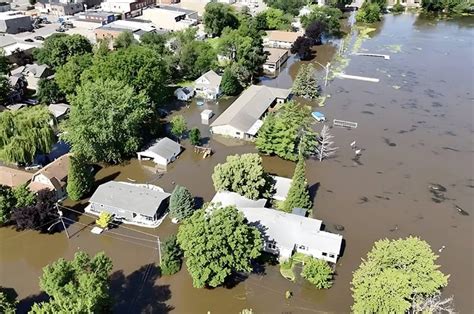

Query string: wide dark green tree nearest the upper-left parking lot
[34,33,92,68]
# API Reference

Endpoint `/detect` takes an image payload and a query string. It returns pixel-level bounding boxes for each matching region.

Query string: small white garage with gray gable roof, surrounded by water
[137,137,181,167]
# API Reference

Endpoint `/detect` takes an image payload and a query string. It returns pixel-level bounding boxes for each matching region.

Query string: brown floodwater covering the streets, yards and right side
[0,14,474,313]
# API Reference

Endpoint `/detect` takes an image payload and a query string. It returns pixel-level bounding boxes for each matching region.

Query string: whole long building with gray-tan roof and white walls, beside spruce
[211,85,290,140]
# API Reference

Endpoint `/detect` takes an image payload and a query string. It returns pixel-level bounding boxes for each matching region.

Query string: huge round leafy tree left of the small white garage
[64,80,153,163]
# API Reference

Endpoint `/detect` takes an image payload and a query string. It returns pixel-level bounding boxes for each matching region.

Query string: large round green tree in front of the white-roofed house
[178,206,263,288]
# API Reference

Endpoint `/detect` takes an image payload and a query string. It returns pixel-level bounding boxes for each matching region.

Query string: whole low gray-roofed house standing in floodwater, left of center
[86,181,170,227]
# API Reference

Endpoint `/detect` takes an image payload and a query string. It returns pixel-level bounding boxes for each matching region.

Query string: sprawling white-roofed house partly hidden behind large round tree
[211,192,342,263]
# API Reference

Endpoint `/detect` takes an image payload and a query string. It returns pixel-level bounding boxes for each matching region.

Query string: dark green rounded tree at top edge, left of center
[203,2,239,37]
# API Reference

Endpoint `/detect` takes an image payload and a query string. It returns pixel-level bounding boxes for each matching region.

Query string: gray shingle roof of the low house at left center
[89,181,170,217]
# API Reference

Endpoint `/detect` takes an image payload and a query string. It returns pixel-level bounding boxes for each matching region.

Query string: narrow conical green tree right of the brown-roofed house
[67,156,94,201]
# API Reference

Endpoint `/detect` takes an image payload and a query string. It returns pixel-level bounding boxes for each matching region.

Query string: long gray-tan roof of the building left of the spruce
[211,85,290,132]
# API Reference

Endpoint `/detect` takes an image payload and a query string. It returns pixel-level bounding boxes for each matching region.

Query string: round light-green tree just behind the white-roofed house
[212,154,271,199]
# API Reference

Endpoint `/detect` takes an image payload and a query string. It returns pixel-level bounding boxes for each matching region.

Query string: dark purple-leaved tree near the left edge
[12,190,58,231]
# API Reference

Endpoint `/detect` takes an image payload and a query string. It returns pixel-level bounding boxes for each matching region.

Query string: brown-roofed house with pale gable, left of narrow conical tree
[28,154,70,199]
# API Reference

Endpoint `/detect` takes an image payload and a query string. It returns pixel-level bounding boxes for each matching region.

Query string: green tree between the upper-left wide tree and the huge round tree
[54,53,92,95]
